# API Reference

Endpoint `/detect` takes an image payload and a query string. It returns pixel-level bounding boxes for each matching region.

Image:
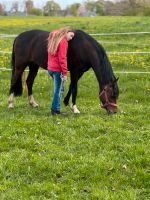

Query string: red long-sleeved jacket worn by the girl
[48,35,68,76]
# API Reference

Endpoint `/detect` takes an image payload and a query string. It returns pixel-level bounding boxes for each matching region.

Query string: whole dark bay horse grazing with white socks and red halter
[8,30,119,113]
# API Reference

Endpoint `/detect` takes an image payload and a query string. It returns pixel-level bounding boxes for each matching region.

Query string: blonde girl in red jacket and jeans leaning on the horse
[48,27,74,115]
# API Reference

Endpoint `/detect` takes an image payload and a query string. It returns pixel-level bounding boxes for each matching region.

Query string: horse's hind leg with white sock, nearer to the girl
[26,64,39,108]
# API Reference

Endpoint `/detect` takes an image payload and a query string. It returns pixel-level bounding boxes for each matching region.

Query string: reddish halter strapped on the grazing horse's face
[99,85,118,109]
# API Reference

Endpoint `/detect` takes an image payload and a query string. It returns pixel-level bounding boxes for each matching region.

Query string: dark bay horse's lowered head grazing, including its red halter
[99,78,119,114]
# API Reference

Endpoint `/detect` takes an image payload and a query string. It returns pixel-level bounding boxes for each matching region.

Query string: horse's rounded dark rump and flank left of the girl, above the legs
[13,30,49,68]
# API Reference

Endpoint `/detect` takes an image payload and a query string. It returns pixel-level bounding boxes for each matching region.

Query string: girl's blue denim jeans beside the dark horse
[48,70,63,111]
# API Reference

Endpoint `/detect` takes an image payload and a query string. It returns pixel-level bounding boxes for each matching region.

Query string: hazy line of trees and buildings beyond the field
[0,0,150,16]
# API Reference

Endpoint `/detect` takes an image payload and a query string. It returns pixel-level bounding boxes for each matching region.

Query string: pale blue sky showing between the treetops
[0,0,115,9]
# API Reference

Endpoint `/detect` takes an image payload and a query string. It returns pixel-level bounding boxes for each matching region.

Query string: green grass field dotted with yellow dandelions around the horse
[0,17,150,200]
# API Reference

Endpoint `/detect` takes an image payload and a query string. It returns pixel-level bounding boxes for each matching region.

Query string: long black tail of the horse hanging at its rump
[9,38,23,96]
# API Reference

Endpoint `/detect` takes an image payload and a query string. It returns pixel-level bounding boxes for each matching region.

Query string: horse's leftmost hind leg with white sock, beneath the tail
[8,66,26,108]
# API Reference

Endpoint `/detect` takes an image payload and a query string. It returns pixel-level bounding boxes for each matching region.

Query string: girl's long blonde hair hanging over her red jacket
[48,27,74,55]
